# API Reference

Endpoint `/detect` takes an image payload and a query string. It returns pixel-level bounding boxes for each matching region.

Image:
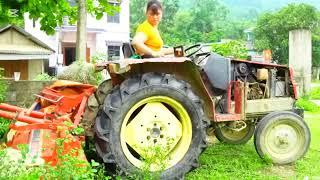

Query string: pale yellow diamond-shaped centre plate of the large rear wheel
[126,102,182,157]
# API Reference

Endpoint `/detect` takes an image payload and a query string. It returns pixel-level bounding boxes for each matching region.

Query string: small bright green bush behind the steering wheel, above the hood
[212,40,248,59]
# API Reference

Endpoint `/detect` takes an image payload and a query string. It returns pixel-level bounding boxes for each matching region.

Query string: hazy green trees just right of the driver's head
[165,0,228,45]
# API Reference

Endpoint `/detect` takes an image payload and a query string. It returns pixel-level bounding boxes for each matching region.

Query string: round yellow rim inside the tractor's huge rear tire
[120,96,192,171]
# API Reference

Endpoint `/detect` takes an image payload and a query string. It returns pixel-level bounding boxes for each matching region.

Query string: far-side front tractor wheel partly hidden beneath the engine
[214,122,255,144]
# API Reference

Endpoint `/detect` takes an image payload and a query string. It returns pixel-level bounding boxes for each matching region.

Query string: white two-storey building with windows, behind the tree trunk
[24,0,130,74]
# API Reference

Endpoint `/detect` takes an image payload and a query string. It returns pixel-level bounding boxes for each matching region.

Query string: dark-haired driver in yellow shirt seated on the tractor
[132,0,173,58]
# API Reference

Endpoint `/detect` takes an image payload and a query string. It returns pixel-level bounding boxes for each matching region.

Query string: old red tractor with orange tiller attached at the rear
[0,43,310,179]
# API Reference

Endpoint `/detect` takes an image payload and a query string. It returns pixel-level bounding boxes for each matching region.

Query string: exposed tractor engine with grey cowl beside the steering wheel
[200,53,293,112]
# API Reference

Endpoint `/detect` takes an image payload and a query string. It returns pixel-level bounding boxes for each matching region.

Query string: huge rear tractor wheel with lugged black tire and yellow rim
[95,73,209,179]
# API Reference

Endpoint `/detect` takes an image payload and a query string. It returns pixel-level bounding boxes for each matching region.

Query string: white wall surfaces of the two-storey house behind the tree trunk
[24,0,130,67]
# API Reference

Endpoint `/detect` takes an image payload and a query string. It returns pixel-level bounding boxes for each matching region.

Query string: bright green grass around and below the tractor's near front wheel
[186,113,320,179]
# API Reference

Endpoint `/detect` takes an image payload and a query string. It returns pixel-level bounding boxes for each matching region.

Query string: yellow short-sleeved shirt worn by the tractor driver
[137,20,163,54]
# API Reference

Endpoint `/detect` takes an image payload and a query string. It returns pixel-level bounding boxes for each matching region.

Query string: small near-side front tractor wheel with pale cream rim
[254,111,311,164]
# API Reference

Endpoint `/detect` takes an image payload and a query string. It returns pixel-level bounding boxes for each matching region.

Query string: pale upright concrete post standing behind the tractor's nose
[289,29,312,96]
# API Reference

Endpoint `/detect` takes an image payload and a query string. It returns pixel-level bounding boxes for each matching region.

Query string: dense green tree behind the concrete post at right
[255,4,319,64]
